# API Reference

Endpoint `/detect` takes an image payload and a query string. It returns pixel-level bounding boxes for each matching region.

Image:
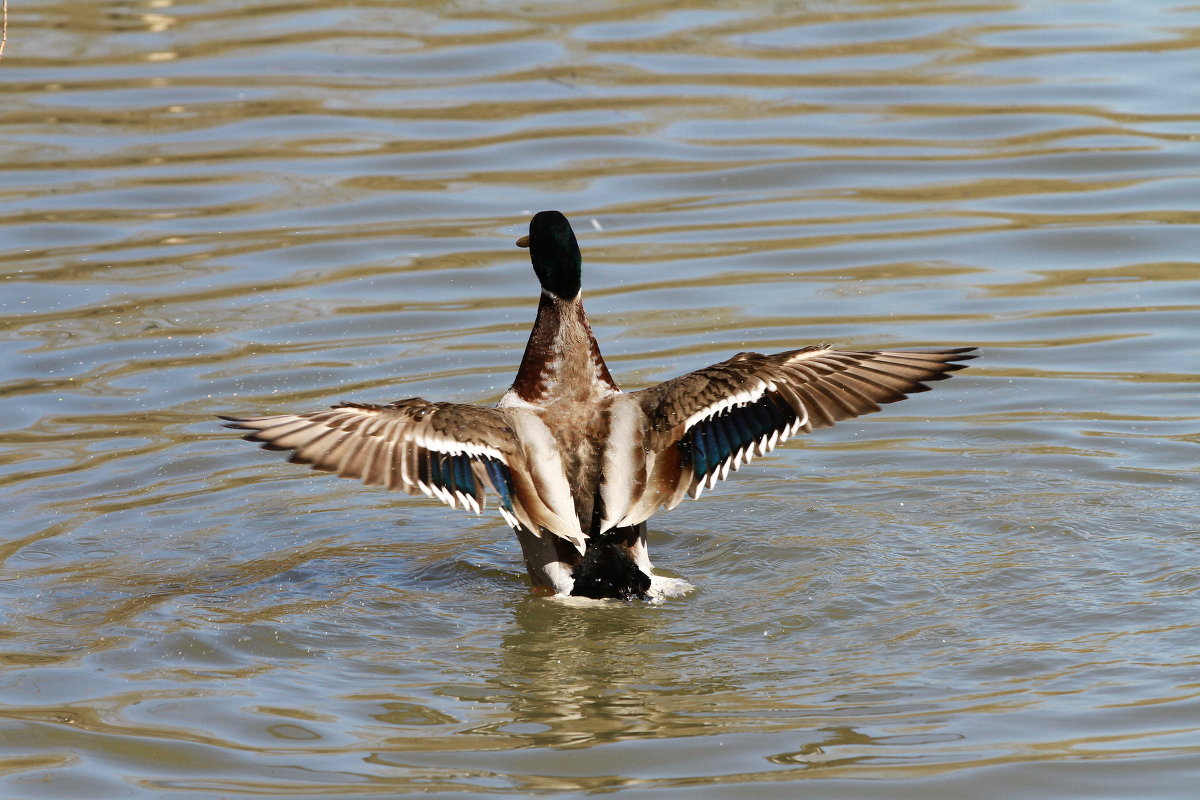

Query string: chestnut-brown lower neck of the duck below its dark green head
[512,291,619,405]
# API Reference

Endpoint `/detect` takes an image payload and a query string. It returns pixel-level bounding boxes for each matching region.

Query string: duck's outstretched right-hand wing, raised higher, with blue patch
[620,345,974,524]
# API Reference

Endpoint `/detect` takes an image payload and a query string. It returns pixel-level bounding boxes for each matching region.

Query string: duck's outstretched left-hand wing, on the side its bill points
[221,397,578,542]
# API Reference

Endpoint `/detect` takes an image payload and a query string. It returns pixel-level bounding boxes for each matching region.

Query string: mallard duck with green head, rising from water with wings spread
[221,211,976,601]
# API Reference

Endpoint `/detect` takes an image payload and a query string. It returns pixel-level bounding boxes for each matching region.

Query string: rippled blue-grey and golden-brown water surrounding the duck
[0,0,1200,799]
